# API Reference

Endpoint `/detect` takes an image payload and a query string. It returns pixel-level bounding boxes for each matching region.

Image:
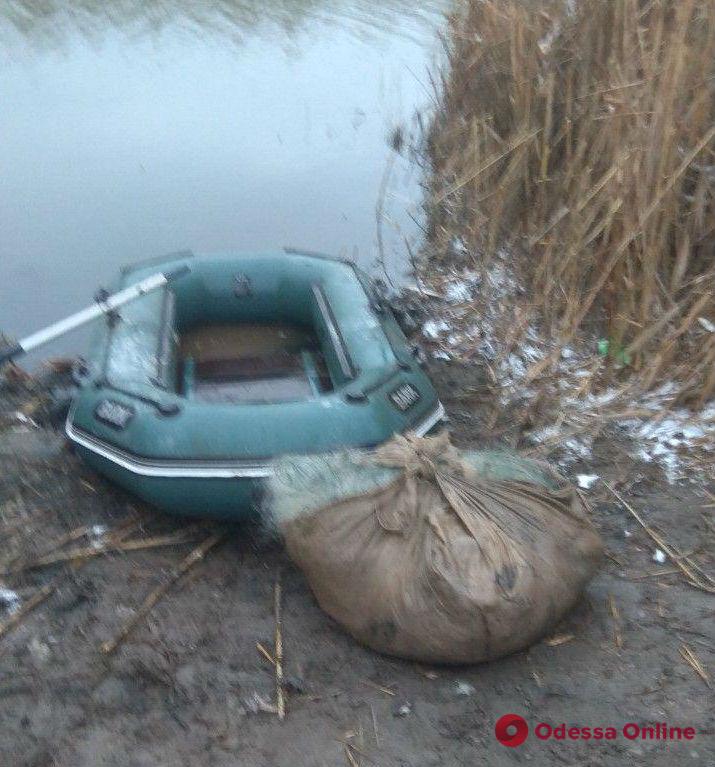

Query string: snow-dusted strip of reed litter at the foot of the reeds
[419,245,715,482]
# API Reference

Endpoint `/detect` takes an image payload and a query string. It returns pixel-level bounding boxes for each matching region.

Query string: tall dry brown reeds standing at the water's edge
[429,0,715,405]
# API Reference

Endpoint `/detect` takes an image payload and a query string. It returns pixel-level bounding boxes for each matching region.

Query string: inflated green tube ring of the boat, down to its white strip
[66,253,444,479]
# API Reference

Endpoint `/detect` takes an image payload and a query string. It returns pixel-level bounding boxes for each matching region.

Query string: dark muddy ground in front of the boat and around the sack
[0,361,715,767]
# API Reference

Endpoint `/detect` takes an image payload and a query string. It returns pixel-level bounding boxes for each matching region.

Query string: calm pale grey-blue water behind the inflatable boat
[0,0,447,364]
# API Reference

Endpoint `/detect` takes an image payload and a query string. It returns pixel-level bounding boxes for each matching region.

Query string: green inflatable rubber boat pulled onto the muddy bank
[66,250,444,519]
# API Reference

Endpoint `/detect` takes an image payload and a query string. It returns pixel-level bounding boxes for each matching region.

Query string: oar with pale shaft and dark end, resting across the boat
[0,266,190,367]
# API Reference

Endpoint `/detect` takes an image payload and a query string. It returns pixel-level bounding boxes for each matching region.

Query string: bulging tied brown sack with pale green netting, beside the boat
[269,433,602,663]
